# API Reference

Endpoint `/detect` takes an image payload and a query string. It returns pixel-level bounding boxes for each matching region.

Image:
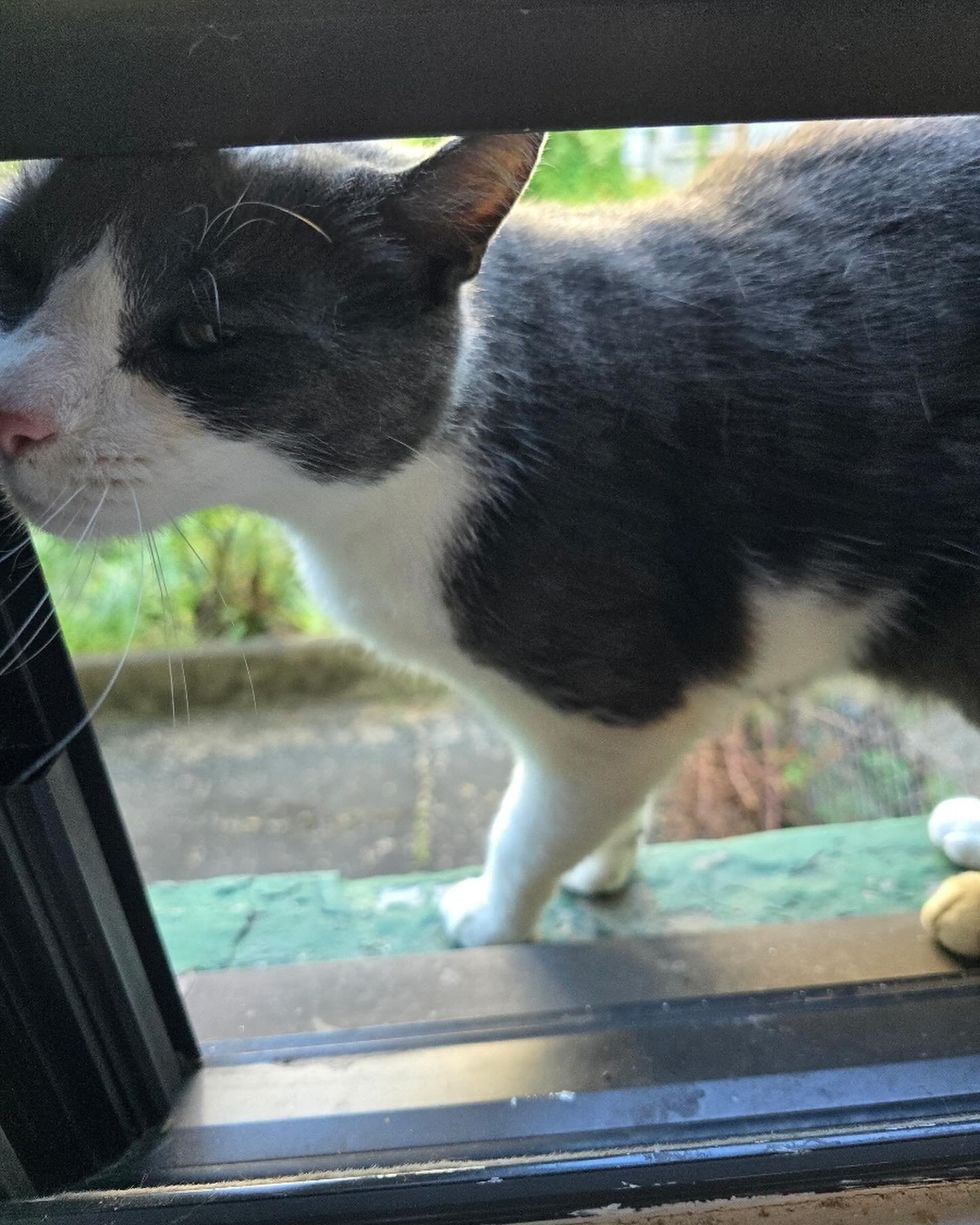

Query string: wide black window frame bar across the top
[0,0,980,159]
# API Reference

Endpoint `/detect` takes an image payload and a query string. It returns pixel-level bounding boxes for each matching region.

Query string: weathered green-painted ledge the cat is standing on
[149,817,951,973]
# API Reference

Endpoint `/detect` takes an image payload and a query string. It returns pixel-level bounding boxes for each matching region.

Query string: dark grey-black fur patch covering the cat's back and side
[446,119,980,723]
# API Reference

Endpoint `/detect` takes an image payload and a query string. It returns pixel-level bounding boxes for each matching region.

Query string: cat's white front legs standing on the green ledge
[441,760,650,946]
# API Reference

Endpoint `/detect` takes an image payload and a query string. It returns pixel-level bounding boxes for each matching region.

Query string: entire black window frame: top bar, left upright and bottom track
[0,0,980,1225]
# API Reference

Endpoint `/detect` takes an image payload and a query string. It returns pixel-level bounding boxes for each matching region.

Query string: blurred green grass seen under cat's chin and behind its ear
[26,130,671,652]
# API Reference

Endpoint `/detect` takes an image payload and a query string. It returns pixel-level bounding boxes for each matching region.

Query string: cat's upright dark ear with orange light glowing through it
[385,132,544,299]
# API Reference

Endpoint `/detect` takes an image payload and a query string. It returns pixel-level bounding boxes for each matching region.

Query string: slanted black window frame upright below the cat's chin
[0,512,200,1194]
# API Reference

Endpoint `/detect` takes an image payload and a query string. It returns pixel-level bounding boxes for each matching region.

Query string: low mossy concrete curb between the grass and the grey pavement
[75,637,445,718]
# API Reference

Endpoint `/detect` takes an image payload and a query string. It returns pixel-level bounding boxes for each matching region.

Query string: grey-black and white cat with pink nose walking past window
[0,119,980,944]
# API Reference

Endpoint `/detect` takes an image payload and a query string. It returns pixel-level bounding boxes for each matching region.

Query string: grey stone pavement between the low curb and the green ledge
[98,698,510,881]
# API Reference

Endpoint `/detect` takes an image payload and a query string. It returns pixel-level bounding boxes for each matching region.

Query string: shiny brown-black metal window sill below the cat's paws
[10,916,980,1225]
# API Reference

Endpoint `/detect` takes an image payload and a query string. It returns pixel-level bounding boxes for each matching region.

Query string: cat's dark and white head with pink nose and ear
[0,134,540,535]
